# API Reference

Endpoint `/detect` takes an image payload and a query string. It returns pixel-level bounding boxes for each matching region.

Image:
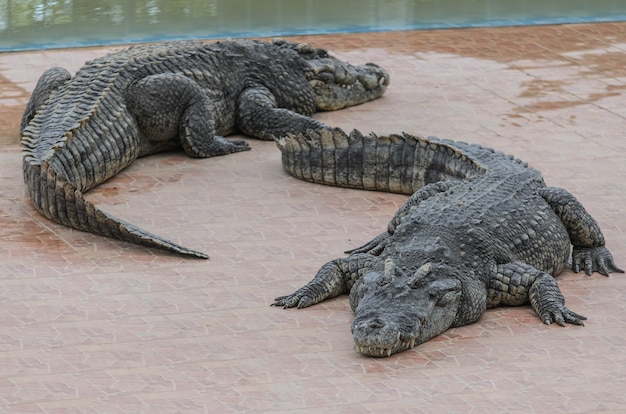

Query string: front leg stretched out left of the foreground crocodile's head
[272,254,381,309]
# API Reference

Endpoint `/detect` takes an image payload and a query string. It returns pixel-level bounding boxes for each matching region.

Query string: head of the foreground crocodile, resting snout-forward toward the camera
[350,259,462,357]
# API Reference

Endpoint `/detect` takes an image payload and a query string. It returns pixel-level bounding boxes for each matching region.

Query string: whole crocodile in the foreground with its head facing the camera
[272,129,623,357]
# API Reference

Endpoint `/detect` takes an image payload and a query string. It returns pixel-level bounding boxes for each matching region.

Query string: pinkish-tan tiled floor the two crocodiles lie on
[0,23,626,413]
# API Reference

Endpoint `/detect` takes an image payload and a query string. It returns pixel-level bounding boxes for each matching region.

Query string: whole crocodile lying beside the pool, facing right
[20,39,389,258]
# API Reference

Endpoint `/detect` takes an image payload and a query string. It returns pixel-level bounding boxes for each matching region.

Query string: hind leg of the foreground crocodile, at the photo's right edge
[539,187,624,276]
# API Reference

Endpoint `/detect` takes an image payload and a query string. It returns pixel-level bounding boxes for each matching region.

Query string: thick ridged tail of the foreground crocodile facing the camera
[276,128,485,194]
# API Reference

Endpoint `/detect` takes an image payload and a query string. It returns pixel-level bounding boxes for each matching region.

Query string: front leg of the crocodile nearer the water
[237,86,330,141]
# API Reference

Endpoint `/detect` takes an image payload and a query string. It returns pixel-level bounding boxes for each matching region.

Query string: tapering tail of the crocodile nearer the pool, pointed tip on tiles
[24,161,208,259]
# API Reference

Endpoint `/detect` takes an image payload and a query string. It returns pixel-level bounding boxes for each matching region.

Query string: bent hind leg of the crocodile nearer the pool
[126,73,250,158]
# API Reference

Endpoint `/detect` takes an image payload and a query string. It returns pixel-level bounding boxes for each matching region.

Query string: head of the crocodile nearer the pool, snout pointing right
[274,40,389,111]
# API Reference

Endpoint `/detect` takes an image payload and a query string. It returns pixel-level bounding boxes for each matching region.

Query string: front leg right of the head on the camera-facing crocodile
[487,262,587,326]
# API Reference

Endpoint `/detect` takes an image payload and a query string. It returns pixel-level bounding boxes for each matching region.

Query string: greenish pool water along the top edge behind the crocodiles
[0,0,626,51]
